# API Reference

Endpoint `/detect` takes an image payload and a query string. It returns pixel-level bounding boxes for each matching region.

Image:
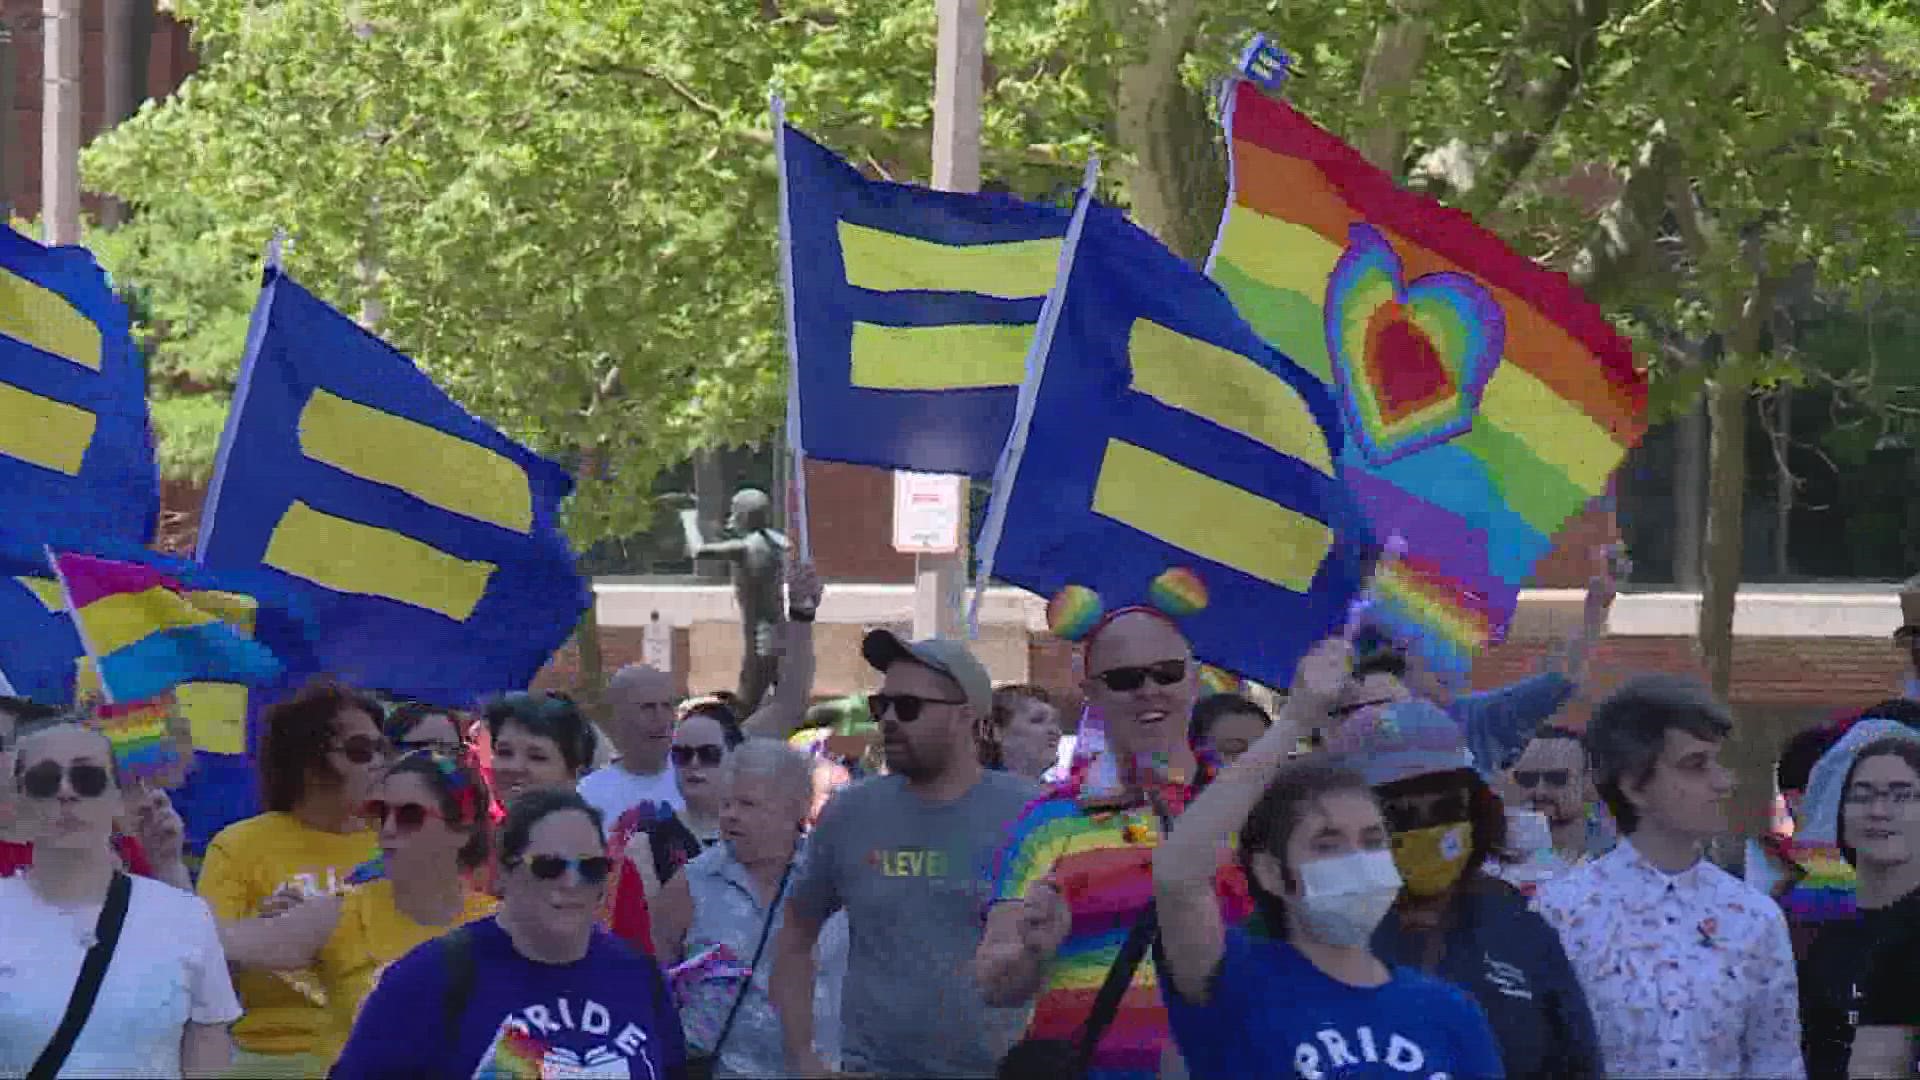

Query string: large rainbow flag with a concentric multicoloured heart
[1208,81,1647,673]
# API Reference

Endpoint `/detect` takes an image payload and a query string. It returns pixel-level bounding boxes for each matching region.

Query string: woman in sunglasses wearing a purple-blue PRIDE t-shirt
[332,788,685,1080]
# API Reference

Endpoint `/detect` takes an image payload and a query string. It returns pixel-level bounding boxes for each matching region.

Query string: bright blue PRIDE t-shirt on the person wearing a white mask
[1160,928,1501,1080]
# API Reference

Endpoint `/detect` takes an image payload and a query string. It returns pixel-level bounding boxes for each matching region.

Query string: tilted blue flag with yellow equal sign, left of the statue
[200,269,589,705]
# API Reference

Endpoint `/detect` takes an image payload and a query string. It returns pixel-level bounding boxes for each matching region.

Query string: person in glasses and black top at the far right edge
[1799,717,1920,1080]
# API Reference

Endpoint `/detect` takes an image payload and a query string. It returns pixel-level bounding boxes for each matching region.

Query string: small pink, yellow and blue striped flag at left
[52,553,280,705]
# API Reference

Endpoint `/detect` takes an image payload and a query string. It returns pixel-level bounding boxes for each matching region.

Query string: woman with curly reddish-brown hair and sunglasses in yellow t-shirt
[200,680,390,1076]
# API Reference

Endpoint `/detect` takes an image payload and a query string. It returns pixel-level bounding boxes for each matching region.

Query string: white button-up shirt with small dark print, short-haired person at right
[1534,840,1807,1080]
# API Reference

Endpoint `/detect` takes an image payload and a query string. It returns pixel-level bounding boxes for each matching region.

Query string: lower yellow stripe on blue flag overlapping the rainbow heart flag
[1092,438,1332,592]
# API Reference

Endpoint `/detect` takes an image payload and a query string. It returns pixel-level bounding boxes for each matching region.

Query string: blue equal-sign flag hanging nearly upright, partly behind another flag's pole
[780,125,1071,479]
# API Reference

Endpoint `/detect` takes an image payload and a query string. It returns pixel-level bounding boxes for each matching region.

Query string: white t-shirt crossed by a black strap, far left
[0,874,240,1076]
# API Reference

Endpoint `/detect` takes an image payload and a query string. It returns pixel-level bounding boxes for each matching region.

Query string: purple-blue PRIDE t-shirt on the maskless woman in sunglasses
[332,919,685,1080]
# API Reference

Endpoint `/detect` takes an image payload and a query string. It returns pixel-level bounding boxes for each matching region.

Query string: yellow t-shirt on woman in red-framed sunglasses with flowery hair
[313,880,499,1067]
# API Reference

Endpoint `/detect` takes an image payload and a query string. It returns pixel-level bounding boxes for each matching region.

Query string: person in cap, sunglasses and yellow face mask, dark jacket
[1327,700,1601,1078]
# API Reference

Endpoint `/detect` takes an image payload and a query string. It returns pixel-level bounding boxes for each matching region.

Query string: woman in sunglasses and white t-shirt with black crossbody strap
[0,721,240,1076]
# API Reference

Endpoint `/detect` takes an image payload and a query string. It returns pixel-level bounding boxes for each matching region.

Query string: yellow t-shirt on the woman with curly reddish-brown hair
[200,813,380,1055]
